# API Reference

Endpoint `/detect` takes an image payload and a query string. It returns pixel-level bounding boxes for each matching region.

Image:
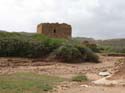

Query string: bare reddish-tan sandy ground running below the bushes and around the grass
[0,56,125,93]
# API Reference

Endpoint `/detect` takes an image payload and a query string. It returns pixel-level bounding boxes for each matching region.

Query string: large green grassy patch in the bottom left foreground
[0,73,63,93]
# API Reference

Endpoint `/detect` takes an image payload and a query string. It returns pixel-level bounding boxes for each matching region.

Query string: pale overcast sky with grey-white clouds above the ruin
[0,0,125,39]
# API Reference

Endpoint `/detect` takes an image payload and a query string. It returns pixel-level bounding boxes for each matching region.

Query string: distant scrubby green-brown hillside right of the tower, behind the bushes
[73,38,125,55]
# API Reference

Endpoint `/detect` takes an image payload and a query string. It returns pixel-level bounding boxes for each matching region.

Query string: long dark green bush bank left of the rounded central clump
[0,32,64,58]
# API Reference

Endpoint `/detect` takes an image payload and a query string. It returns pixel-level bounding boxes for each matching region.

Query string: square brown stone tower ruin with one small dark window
[37,23,72,39]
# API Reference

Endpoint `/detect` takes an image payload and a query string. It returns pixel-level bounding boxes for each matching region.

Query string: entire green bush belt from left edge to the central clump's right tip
[0,32,98,62]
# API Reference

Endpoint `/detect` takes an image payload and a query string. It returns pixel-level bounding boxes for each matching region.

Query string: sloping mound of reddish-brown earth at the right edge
[93,59,125,85]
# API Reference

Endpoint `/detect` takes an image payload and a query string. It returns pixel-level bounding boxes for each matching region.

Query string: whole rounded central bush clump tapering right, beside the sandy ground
[50,43,99,62]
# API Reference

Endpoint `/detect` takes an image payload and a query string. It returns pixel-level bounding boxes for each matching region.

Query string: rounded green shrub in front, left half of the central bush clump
[54,44,82,62]
